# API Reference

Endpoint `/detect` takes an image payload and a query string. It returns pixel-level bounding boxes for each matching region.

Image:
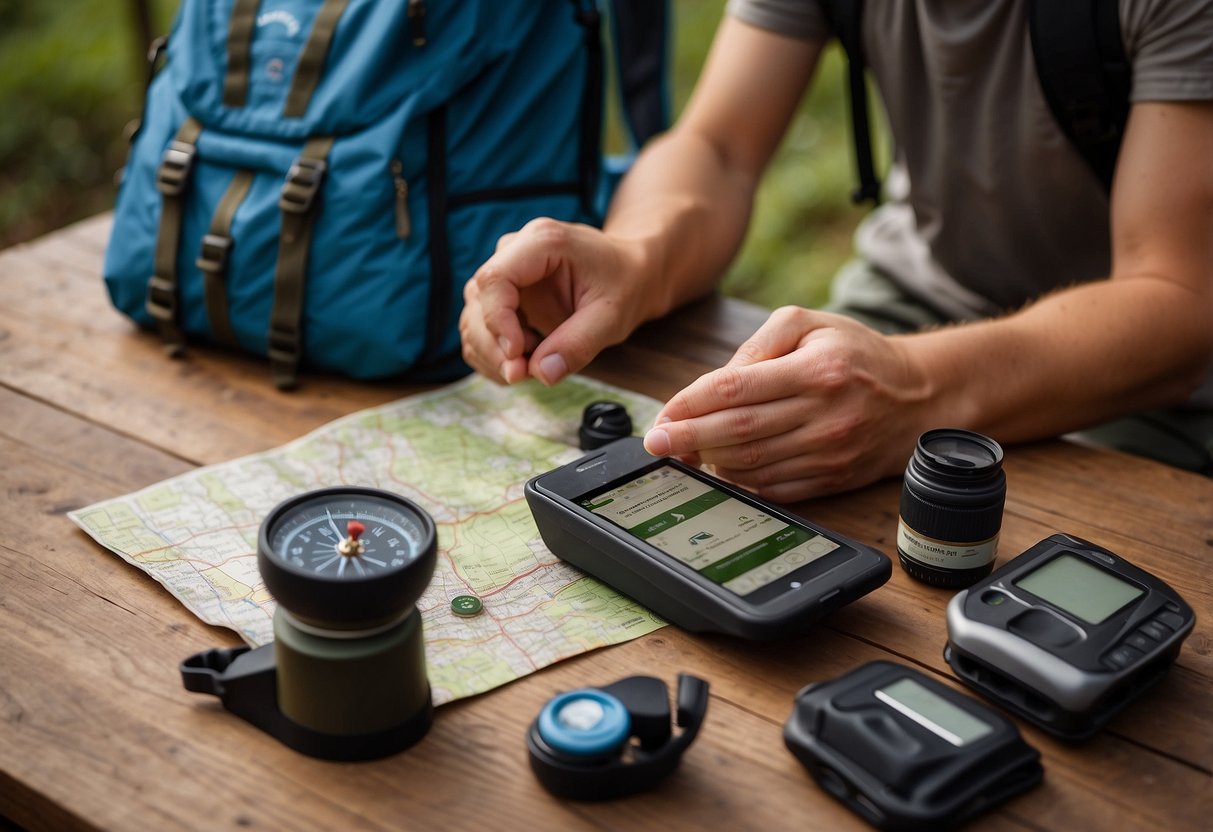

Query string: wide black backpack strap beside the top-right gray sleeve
[1027,0,1133,192]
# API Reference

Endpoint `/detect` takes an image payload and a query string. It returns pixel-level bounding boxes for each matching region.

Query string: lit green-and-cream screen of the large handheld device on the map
[577,465,839,595]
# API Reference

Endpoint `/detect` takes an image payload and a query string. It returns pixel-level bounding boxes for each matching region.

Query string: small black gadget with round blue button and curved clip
[526,673,708,800]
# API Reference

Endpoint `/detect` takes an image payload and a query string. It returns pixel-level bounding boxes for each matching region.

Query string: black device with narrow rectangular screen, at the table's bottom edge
[784,661,1043,831]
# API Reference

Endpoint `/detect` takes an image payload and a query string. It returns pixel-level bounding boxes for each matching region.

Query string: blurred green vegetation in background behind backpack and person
[0,0,859,307]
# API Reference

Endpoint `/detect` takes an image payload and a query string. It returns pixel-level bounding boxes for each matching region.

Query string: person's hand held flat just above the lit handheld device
[644,307,930,502]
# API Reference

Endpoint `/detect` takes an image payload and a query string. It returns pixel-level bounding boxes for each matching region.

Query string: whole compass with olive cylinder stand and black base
[181,486,438,760]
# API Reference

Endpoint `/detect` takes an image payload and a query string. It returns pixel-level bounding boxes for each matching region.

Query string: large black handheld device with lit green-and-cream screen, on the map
[525,437,893,639]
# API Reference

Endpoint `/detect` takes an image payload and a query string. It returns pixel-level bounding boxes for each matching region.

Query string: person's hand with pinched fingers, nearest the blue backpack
[460,218,644,384]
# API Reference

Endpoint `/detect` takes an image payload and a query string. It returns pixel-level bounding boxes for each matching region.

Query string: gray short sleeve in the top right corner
[1121,0,1213,101]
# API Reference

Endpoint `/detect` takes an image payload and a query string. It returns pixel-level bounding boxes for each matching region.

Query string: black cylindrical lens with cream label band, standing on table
[898,428,1007,587]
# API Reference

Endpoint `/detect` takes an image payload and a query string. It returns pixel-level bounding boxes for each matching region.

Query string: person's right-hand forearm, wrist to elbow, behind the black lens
[901,275,1213,441]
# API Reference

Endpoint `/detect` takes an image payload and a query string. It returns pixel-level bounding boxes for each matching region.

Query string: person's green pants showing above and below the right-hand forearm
[825,260,1213,477]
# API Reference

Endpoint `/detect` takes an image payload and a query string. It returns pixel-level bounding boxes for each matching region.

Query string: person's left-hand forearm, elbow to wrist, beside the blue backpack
[596,15,822,327]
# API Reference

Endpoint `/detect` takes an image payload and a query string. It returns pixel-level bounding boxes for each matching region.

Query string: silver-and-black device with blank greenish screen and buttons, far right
[944,535,1196,741]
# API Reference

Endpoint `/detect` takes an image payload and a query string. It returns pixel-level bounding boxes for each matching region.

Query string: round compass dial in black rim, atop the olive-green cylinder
[257,486,438,629]
